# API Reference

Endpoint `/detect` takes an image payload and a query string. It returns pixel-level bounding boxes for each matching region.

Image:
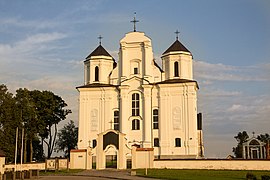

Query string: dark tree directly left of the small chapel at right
[233,131,249,158]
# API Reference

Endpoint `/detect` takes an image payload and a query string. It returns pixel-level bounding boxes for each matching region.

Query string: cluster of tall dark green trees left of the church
[0,84,71,162]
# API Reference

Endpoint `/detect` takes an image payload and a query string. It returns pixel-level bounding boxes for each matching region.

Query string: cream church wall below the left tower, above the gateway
[78,87,118,149]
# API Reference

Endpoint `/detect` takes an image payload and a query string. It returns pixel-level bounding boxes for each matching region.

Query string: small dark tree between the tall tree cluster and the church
[55,120,78,158]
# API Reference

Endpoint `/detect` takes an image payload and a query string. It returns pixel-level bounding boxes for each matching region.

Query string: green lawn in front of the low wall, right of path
[136,169,270,180]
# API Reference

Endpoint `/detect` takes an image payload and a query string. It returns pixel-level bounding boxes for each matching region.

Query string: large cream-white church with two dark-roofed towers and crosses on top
[73,18,204,169]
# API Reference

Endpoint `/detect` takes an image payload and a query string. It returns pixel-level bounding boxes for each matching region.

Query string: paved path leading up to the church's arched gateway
[39,169,158,180]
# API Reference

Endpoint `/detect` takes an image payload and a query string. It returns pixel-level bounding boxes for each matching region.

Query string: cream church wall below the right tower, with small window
[159,84,198,156]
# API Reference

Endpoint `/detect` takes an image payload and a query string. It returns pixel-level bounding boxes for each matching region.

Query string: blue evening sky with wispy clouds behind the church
[0,0,270,157]
